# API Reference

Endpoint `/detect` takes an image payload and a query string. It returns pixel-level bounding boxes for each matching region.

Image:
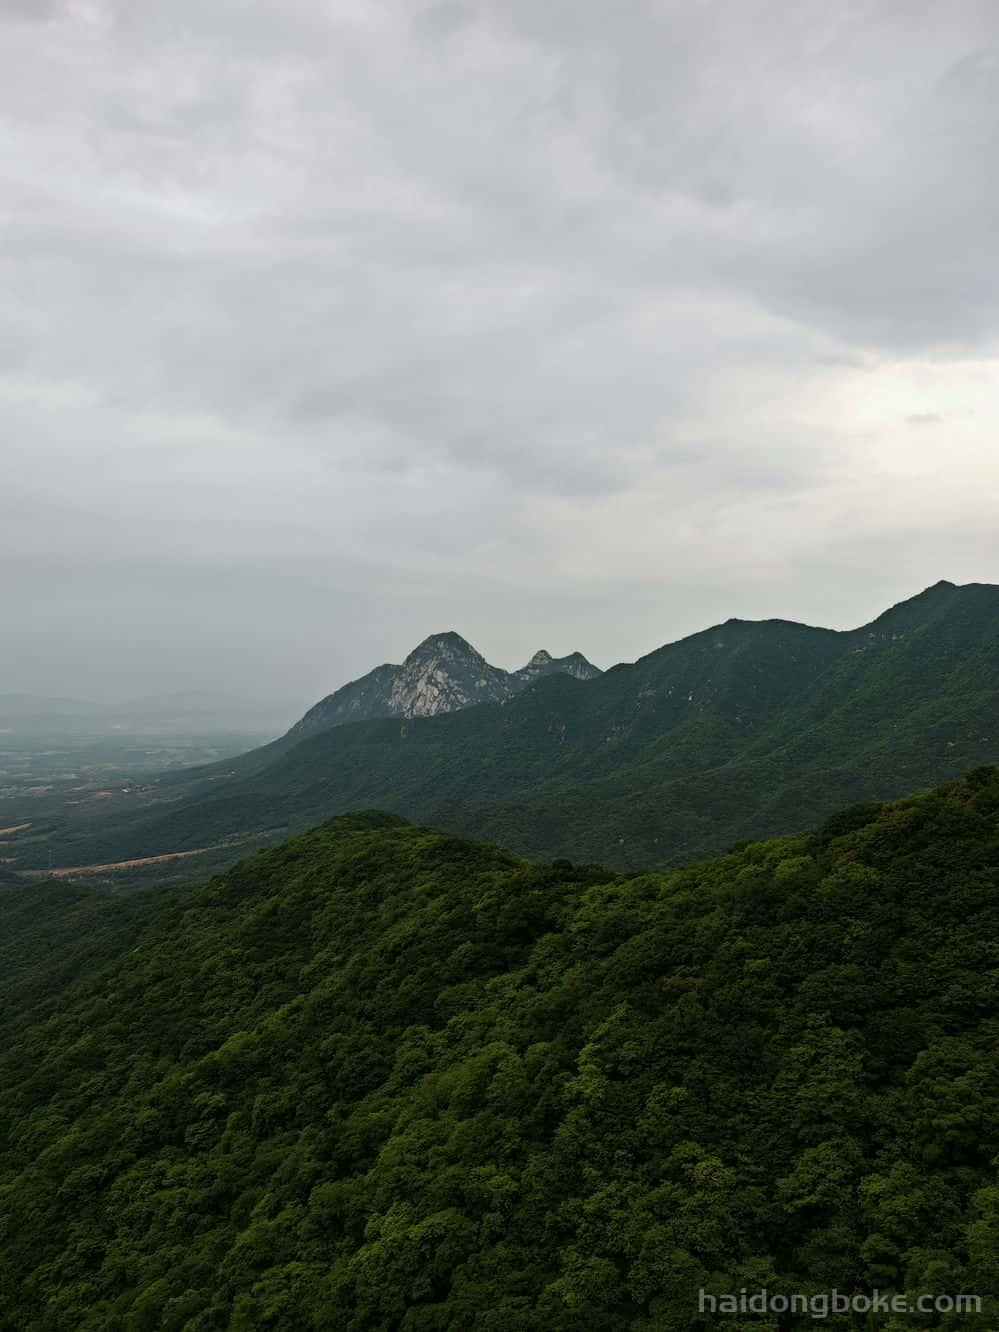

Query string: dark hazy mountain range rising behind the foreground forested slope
[12,582,999,874]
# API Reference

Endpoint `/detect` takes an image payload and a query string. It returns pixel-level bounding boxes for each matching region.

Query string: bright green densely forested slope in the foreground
[0,769,999,1332]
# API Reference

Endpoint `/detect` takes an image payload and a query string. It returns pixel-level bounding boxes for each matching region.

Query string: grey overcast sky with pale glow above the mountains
[0,0,999,703]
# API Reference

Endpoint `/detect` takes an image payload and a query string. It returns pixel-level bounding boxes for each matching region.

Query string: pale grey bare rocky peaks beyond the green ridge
[289,631,601,739]
